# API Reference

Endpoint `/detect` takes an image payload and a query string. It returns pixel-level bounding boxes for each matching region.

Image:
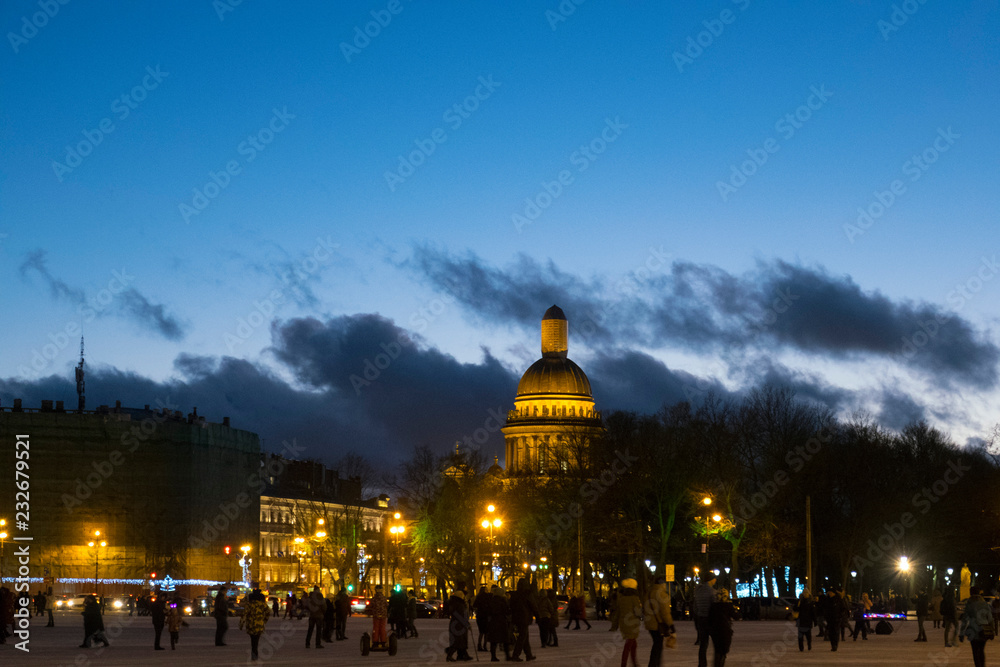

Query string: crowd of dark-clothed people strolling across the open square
[7,573,1000,667]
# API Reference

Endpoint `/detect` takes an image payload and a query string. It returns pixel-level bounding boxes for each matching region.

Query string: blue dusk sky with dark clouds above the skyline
[0,0,1000,463]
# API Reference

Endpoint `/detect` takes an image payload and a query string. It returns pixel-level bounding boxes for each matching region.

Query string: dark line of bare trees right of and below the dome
[388,386,1000,595]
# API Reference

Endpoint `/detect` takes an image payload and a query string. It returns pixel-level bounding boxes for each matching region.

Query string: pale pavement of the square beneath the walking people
[0,612,988,667]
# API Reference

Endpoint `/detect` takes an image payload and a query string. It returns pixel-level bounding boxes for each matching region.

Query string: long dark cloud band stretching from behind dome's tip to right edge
[411,246,1000,389]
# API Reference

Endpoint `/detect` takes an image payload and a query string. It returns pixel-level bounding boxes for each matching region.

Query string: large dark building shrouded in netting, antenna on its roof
[0,399,261,594]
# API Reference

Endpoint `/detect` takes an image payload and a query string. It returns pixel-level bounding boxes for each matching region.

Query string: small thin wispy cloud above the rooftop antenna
[20,249,184,341]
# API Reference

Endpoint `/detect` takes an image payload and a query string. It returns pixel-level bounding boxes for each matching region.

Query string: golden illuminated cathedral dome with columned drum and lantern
[502,306,604,476]
